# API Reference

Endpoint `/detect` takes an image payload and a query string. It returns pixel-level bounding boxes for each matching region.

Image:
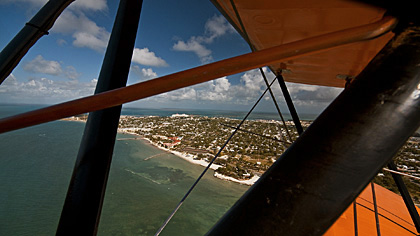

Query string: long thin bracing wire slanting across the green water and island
[155,77,277,236]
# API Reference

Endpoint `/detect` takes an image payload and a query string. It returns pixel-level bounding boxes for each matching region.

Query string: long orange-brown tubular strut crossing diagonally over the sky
[0,17,397,133]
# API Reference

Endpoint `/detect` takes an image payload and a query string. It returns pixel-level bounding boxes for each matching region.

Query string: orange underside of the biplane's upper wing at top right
[213,0,393,87]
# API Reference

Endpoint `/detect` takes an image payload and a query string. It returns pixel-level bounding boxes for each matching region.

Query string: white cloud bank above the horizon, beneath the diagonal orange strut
[146,68,342,112]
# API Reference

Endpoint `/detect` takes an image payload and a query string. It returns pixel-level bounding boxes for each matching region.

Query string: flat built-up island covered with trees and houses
[63,114,420,203]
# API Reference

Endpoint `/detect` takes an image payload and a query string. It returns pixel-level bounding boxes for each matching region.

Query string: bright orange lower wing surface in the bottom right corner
[324,184,417,236]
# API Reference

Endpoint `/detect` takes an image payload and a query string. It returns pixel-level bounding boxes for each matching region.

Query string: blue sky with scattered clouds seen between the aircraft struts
[0,0,341,113]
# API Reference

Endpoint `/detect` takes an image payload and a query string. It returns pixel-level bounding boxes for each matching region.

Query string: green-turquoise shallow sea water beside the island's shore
[0,106,247,236]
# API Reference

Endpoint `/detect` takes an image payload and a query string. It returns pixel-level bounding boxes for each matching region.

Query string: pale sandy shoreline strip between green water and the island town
[62,117,259,186]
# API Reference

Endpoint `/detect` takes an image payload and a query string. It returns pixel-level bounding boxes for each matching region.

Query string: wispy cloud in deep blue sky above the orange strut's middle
[172,15,235,63]
